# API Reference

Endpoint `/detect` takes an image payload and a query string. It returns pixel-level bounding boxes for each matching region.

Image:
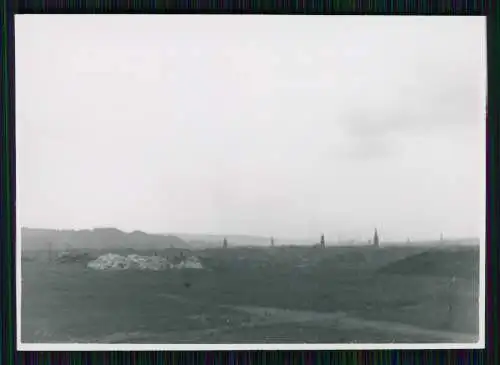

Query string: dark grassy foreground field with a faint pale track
[21,243,479,343]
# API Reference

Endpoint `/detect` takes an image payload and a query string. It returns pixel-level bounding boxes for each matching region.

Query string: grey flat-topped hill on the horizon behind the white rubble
[21,228,190,251]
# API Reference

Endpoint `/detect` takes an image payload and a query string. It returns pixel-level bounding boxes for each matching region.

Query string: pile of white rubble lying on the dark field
[87,253,203,271]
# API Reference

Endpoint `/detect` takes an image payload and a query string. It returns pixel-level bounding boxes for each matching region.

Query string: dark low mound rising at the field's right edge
[379,248,479,279]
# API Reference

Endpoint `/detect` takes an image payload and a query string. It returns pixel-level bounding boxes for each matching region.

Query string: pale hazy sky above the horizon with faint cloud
[15,15,486,239]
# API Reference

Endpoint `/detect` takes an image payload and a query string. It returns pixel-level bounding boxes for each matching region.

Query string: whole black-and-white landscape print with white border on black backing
[15,14,487,350]
